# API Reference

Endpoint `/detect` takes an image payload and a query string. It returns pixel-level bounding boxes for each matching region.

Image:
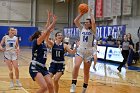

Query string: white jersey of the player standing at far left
[4,35,17,51]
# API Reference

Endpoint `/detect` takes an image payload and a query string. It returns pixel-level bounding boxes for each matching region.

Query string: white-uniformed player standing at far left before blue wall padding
[0,28,22,88]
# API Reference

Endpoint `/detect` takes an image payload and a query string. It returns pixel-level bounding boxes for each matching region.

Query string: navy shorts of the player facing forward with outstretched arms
[49,62,65,75]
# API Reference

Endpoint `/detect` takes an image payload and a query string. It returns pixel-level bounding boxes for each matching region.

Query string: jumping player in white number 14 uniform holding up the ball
[70,9,96,93]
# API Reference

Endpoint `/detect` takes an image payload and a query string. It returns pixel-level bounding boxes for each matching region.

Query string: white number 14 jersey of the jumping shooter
[80,27,94,48]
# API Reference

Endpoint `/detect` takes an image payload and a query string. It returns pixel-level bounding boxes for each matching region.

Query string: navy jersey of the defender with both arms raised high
[32,40,47,64]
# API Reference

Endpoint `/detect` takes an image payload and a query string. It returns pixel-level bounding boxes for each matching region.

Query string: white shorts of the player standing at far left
[4,51,17,60]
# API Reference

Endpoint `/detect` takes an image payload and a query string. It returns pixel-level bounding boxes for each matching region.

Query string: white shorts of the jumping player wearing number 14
[76,47,93,61]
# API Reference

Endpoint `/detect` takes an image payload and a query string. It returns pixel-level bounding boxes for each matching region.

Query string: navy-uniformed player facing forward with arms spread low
[47,32,76,93]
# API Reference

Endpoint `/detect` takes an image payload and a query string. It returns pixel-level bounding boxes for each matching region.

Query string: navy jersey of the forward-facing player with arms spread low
[52,43,65,61]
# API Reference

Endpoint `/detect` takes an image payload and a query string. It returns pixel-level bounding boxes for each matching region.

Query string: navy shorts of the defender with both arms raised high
[29,63,49,81]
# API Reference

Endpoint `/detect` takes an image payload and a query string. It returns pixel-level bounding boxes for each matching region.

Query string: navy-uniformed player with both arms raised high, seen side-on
[29,12,56,93]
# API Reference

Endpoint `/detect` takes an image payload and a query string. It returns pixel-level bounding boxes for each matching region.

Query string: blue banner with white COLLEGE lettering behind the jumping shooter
[63,25,126,39]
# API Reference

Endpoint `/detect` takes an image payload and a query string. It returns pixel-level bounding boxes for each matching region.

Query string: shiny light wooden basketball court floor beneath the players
[0,48,140,93]
